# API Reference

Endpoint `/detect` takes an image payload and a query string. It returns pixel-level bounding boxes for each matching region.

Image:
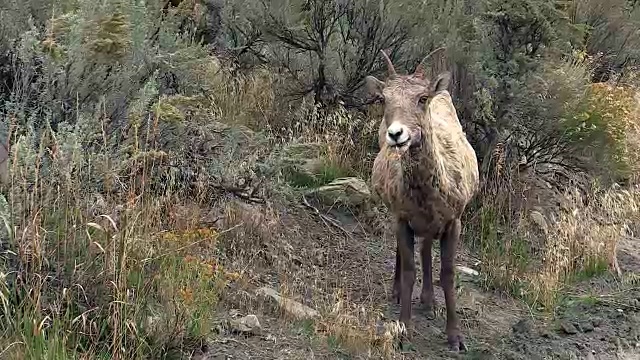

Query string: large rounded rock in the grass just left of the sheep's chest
[312,177,371,206]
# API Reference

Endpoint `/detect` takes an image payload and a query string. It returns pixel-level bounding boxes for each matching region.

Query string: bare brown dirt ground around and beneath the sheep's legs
[199,198,640,360]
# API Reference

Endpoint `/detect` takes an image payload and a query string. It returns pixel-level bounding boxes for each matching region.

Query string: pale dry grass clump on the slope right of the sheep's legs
[466,170,640,310]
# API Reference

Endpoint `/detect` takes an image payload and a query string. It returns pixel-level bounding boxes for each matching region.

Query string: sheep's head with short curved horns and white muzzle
[365,48,451,152]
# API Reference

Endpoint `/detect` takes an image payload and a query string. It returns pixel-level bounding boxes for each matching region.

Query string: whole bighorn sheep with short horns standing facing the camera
[365,49,479,351]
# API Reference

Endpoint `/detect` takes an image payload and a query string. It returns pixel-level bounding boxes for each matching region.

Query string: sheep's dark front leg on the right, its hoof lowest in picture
[440,219,467,352]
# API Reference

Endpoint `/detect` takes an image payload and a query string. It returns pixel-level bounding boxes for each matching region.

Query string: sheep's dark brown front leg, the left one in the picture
[396,221,416,327]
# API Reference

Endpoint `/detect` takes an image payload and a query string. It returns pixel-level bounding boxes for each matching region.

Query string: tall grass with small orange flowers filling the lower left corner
[0,114,238,359]
